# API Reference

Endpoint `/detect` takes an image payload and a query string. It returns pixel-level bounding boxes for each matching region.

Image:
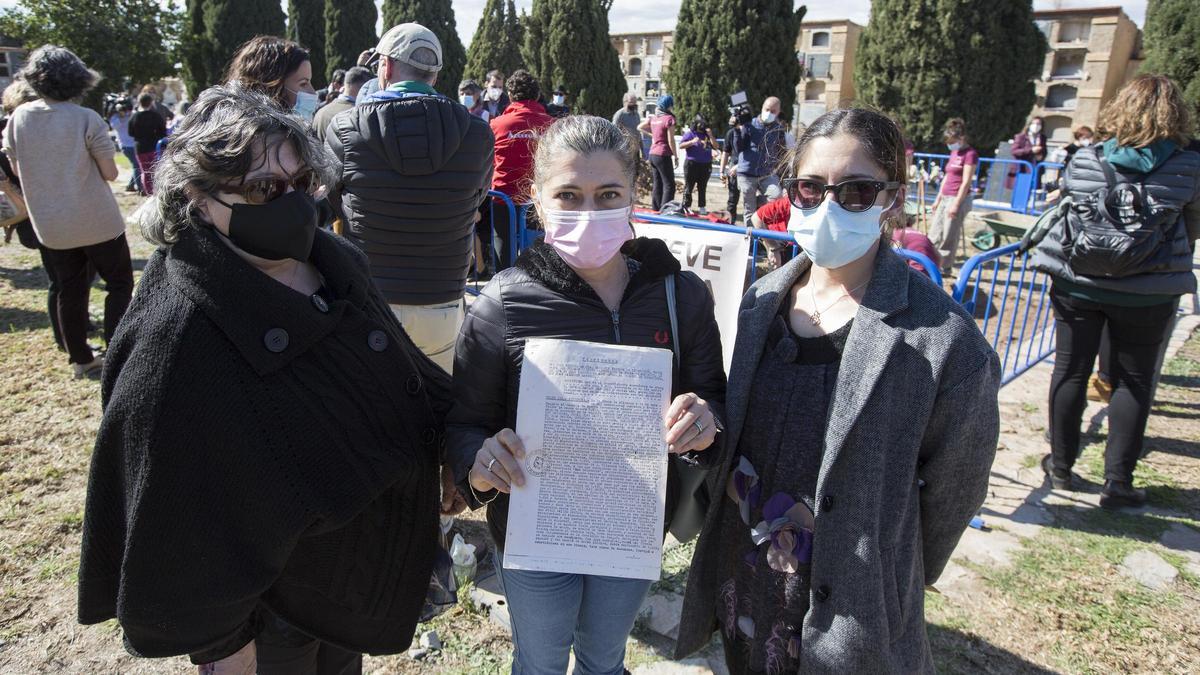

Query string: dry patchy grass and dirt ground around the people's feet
[0,174,1200,674]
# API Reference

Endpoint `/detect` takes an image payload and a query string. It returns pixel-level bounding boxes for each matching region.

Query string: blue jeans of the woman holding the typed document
[497,550,650,675]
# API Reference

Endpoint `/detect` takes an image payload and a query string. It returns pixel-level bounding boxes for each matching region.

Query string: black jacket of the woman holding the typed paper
[446,238,725,546]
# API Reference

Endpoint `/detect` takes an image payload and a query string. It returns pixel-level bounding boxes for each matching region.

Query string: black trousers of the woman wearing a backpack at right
[1050,288,1176,482]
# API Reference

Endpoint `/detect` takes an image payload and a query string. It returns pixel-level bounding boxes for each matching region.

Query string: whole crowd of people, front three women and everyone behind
[0,10,1200,675]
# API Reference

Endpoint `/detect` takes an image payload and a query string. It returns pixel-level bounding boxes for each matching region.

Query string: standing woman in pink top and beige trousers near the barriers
[929,118,979,274]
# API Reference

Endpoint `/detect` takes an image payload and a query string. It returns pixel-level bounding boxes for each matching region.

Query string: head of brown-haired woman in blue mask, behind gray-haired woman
[224,35,320,123]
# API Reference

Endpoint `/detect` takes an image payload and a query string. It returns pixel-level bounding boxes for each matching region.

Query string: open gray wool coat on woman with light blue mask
[677,247,1000,674]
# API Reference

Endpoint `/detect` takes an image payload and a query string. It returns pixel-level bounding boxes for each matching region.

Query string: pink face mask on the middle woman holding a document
[541,207,634,269]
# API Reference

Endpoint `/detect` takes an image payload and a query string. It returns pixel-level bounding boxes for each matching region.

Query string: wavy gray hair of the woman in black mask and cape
[136,85,341,246]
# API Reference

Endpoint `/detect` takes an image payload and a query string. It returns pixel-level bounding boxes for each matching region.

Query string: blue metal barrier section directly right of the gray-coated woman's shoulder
[954,244,1055,384]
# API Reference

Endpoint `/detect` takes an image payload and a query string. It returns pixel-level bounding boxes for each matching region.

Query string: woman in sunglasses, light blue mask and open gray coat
[677,109,1000,674]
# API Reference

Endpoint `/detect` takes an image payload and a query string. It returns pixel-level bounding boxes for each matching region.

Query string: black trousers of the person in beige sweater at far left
[46,234,133,364]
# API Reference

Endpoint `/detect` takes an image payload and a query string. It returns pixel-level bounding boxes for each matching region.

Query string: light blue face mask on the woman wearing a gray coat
[787,198,884,269]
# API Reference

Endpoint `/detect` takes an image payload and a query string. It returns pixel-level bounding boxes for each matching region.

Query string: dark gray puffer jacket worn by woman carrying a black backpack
[1032,147,1200,295]
